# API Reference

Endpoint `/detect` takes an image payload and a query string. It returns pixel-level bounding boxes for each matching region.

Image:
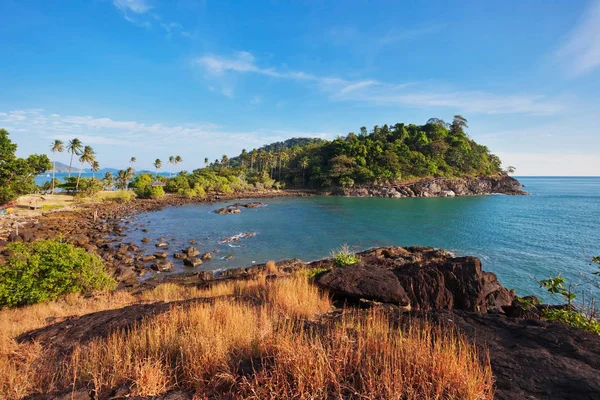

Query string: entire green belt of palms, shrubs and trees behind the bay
[0,115,514,204]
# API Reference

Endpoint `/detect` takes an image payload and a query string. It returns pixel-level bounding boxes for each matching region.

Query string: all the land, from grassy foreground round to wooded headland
[0,116,600,400]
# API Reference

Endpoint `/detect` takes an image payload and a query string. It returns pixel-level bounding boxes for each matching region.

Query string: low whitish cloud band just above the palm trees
[0,109,341,168]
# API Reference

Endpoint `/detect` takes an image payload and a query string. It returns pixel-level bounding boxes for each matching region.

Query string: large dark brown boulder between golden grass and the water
[312,247,515,312]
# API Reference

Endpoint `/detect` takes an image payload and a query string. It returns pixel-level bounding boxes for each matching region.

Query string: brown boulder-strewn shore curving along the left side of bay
[0,190,314,287]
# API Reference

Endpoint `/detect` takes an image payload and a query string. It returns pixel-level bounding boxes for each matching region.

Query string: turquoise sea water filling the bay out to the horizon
[130,177,600,295]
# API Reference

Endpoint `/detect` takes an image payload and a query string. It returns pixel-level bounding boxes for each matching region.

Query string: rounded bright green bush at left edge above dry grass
[0,240,116,307]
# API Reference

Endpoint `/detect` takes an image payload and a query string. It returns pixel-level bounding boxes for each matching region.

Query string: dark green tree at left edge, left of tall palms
[0,129,52,205]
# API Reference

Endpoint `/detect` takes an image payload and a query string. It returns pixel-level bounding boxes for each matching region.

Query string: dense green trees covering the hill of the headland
[226,115,504,188]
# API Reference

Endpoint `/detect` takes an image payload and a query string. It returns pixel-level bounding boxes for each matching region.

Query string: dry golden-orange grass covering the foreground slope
[0,275,493,400]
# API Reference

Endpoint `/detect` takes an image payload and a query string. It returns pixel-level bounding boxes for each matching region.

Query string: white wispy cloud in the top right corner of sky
[556,0,600,76]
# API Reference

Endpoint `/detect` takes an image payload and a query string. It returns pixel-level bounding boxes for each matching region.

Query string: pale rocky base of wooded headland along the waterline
[336,175,526,198]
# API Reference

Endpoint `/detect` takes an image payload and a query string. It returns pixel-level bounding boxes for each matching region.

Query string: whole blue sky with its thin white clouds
[0,0,600,175]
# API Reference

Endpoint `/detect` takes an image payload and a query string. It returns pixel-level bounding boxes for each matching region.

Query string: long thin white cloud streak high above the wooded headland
[195,51,565,115]
